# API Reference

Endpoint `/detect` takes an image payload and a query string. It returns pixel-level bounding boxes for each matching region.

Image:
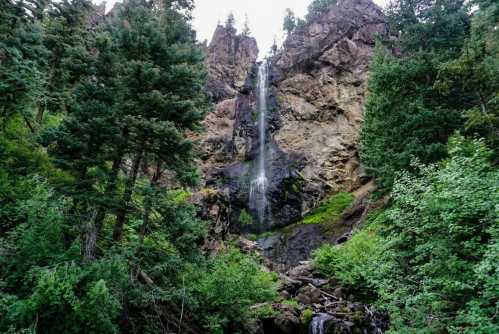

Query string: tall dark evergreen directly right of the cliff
[361,0,469,190]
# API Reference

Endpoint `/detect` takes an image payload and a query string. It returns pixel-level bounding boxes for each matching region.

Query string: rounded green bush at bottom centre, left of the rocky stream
[190,249,277,333]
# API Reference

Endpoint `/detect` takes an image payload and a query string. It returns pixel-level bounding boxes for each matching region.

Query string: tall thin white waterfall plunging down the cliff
[249,61,269,223]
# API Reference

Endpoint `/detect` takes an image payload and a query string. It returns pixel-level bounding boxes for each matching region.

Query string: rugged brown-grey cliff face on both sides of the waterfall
[197,0,388,241]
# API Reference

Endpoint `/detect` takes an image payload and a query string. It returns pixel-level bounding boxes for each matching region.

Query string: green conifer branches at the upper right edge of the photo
[435,1,499,152]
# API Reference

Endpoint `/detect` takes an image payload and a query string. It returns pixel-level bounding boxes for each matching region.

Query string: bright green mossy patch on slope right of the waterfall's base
[300,192,354,224]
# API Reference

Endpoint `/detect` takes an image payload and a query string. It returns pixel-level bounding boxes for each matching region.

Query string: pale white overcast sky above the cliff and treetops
[94,0,387,56]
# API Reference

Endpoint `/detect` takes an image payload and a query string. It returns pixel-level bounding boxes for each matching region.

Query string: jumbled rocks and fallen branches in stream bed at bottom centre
[245,262,389,334]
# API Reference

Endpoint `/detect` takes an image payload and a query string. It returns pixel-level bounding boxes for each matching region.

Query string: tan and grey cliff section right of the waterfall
[274,0,388,205]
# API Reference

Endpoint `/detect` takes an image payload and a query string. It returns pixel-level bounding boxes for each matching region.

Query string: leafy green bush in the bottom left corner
[6,261,127,333]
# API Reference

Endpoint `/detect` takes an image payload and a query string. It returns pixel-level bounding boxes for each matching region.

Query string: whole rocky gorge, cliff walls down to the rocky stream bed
[196,0,389,334]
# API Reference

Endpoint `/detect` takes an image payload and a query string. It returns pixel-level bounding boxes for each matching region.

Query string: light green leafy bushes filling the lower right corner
[330,136,499,333]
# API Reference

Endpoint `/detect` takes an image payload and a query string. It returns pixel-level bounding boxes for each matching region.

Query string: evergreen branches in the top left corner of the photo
[0,0,48,132]
